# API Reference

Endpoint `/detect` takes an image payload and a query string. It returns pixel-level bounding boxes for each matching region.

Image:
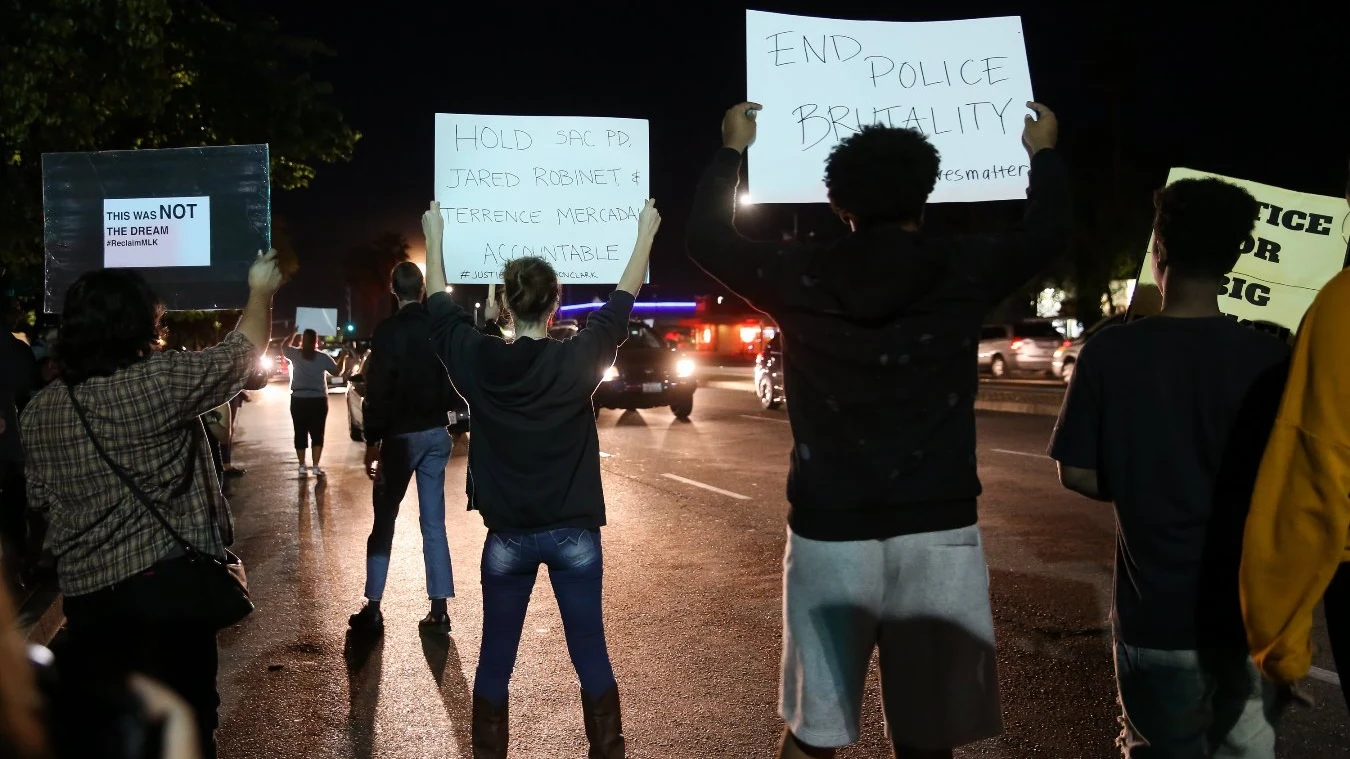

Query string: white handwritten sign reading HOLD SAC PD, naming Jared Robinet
[435,113,649,285]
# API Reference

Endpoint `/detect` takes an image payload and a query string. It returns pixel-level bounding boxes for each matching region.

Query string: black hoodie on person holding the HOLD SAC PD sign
[427,290,633,533]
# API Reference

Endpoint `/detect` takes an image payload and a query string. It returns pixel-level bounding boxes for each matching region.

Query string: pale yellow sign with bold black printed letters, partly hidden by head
[1130,169,1350,336]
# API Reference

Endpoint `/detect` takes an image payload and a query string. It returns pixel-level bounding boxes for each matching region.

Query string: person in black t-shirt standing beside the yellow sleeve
[1050,180,1289,759]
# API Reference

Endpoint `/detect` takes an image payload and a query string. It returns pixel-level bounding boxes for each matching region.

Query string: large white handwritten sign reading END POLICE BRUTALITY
[745,11,1033,203]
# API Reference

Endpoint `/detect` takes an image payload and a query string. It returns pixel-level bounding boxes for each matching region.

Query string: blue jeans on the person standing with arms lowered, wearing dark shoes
[366,427,455,601]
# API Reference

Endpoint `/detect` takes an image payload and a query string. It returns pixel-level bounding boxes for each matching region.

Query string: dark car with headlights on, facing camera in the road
[594,316,698,420]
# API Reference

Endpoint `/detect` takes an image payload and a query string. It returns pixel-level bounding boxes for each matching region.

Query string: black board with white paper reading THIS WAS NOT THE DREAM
[42,145,271,313]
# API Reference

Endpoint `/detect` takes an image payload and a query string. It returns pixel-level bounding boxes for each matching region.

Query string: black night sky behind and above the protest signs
[244,0,1350,318]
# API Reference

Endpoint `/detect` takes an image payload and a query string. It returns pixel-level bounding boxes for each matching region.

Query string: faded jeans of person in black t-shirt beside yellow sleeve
[1115,640,1276,759]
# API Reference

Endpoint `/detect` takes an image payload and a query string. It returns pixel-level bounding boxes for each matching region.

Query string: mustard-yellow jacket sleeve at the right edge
[1241,270,1350,683]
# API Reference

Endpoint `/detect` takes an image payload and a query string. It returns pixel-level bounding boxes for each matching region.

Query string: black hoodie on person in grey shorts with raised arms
[689,149,1069,540]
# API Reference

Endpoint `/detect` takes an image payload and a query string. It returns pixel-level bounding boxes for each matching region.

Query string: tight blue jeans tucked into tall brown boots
[474,528,614,705]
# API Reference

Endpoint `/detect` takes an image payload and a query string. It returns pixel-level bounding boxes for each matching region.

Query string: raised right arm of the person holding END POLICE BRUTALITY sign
[975,103,1072,304]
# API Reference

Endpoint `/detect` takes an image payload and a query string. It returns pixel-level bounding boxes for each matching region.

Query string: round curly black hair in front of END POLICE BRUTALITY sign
[825,124,941,224]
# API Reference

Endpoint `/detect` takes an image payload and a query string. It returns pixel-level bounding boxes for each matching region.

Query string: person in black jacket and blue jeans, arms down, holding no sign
[350,261,458,635]
